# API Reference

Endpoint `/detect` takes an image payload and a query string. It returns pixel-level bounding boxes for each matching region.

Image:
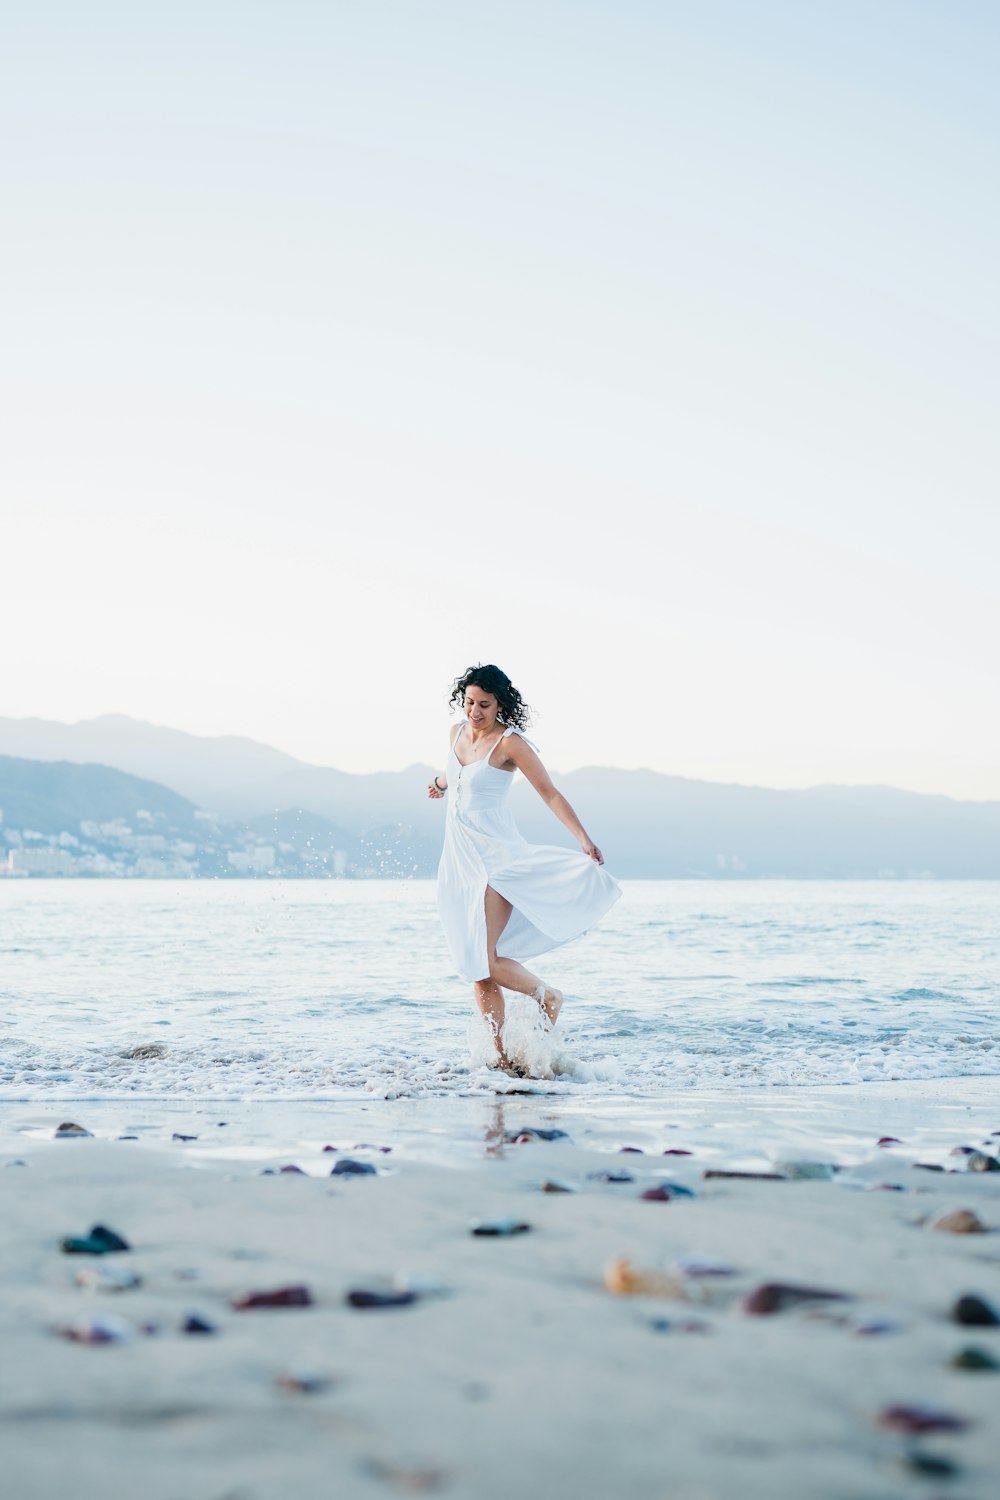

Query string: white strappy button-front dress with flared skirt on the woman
[438,726,622,981]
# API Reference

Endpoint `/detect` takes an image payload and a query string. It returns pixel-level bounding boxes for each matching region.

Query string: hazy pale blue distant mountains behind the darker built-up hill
[0,714,1000,879]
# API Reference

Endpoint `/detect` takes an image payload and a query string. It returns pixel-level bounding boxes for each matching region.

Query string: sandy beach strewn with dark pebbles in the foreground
[0,1080,1000,1500]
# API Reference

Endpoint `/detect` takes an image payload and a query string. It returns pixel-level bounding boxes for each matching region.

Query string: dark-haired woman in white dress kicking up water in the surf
[427,666,622,1071]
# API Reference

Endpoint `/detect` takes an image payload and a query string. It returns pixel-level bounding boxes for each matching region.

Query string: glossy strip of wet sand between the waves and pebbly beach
[0,1076,1000,1166]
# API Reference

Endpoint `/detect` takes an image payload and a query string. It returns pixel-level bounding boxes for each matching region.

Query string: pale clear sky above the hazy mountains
[0,0,1000,798]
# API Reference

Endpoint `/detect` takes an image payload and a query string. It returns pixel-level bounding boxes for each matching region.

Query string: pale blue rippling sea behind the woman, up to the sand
[0,879,1000,1110]
